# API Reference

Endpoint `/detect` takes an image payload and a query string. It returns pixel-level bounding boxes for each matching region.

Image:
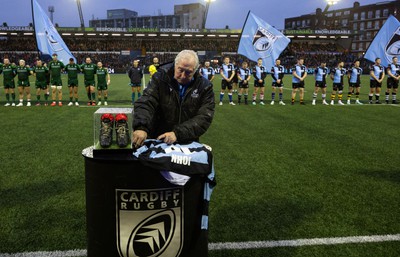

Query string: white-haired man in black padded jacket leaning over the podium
[132,50,215,147]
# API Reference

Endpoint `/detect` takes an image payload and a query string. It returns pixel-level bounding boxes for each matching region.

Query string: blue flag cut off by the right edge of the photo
[364,15,400,67]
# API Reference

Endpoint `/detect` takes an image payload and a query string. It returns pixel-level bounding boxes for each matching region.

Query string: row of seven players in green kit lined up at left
[0,54,110,106]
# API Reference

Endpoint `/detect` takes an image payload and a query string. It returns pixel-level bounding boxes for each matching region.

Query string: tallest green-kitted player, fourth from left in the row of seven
[47,54,65,106]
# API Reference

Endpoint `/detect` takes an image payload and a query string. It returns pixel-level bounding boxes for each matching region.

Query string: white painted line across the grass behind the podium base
[0,234,400,257]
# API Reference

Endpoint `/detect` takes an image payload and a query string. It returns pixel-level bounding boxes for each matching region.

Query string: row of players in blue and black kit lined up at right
[200,57,400,105]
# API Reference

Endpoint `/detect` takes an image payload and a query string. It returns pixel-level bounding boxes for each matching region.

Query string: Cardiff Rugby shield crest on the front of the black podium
[115,188,184,257]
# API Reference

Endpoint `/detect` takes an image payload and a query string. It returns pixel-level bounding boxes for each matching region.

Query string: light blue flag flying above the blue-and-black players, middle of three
[238,12,290,70]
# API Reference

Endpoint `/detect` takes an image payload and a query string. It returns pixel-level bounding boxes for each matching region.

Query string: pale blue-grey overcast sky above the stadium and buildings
[0,0,381,29]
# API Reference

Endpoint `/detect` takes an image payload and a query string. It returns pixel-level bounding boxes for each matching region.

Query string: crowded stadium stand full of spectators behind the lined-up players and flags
[0,36,370,72]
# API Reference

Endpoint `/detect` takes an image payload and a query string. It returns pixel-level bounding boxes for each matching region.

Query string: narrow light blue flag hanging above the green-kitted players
[32,0,76,63]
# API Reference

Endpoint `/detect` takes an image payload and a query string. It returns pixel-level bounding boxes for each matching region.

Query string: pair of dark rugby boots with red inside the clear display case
[100,113,130,148]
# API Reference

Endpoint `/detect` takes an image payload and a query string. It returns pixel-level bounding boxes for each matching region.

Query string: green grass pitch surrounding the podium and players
[0,75,400,257]
